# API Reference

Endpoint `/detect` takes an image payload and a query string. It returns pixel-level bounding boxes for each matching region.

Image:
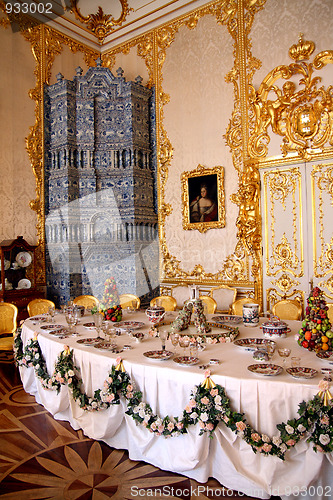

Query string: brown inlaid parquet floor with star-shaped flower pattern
[0,352,273,500]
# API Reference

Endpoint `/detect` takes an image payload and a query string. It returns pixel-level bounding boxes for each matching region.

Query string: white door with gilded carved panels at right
[260,161,333,310]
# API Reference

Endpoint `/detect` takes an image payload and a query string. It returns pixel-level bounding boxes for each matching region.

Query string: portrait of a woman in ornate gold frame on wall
[181,165,225,233]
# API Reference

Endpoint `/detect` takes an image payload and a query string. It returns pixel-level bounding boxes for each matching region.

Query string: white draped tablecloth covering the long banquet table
[20,311,333,500]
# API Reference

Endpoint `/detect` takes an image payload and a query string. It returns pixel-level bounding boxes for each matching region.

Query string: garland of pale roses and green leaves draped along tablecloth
[14,329,333,460]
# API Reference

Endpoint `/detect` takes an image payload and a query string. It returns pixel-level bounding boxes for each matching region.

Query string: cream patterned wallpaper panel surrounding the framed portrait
[163,16,238,273]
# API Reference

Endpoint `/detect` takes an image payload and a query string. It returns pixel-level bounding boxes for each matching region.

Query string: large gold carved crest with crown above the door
[248,34,333,159]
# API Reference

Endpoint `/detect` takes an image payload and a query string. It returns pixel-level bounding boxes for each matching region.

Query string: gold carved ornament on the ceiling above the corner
[67,0,133,44]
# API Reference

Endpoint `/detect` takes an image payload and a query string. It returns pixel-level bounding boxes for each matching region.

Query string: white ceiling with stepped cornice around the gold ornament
[32,0,208,52]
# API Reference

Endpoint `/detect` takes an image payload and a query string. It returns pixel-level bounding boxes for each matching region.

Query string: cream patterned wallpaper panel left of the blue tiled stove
[0,28,37,244]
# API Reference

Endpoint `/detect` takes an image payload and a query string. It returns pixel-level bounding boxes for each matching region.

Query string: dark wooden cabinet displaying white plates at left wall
[0,236,44,321]
